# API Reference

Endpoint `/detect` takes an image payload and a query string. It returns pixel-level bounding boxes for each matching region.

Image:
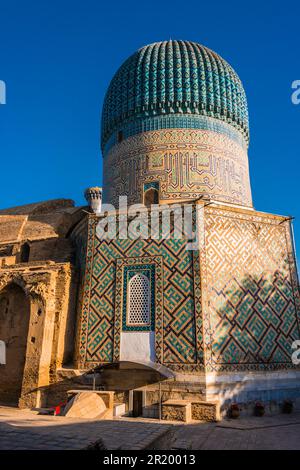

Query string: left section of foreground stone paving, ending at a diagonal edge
[0,407,170,450]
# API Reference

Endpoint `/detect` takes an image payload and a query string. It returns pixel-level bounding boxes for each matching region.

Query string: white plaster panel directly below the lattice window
[120,331,155,363]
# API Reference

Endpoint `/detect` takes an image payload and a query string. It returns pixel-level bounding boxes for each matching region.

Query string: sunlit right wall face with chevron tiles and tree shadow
[205,210,299,370]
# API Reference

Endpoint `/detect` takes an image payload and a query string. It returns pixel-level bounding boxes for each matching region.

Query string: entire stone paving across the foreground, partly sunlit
[0,407,300,450]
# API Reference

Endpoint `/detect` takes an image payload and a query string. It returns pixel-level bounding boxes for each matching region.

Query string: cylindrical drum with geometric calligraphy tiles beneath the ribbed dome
[103,129,252,207]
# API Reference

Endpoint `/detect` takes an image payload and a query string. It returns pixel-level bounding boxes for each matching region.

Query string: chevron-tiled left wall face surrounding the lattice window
[80,207,203,367]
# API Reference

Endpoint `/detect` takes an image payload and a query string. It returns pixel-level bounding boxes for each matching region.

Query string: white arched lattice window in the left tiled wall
[127,274,150,325]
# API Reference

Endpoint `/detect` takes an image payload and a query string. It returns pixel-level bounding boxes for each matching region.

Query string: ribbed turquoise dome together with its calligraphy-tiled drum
[102,40,252,207]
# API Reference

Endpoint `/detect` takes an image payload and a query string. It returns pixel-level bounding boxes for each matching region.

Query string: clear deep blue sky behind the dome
[0,0,300,256]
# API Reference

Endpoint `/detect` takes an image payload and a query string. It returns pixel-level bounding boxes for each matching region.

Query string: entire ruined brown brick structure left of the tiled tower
[0,199,84,406]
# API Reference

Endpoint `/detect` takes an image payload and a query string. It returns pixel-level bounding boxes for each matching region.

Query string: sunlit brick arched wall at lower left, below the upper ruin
[0,262,75,407]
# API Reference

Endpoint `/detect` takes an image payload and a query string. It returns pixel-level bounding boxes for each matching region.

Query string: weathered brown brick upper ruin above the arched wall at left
[0,199,84,266]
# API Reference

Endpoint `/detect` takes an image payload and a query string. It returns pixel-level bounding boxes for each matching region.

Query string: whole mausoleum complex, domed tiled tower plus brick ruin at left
[0,40,300,416]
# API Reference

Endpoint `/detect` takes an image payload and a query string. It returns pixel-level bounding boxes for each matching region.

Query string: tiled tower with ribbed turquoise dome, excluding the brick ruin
[77,41,300,400]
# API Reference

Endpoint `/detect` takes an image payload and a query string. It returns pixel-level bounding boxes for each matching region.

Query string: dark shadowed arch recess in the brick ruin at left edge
[0,283,30,404]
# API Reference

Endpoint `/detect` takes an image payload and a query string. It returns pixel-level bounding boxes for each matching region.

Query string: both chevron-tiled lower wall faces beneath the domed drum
[75,205,300,372]
